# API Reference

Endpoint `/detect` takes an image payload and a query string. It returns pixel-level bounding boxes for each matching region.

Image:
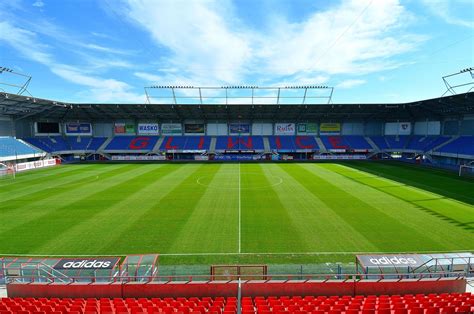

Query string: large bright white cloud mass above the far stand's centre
[118,0,426,84]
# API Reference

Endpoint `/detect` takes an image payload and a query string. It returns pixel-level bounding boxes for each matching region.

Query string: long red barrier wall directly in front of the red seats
[7,278,466,298]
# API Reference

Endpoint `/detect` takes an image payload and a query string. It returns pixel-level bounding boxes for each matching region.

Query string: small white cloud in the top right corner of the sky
[422,0,474,28]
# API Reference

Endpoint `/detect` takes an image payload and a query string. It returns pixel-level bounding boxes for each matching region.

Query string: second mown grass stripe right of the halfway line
[261,164,377,252]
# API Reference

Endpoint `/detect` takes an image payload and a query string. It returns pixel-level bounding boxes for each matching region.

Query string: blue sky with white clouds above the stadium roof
[0,0,474,103]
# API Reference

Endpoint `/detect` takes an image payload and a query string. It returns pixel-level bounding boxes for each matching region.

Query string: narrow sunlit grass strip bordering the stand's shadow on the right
[328,165,474,232]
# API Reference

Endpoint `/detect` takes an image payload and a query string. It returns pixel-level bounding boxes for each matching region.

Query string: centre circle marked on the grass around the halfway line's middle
[196,172,283,190]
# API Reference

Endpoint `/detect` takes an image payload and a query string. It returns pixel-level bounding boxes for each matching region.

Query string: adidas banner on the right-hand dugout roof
[357,254,429,268]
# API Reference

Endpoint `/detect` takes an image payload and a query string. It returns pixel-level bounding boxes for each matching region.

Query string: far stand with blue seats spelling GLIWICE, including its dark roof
[0,92,474,173]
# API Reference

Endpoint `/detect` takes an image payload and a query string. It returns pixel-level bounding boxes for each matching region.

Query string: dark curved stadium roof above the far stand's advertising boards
[0,92,474,122]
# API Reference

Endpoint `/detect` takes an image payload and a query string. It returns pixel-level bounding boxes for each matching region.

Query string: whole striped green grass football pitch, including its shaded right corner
[0,162,474,264]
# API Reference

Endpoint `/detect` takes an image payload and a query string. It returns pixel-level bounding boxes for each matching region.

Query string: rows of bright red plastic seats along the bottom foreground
[0,293,474,314]
